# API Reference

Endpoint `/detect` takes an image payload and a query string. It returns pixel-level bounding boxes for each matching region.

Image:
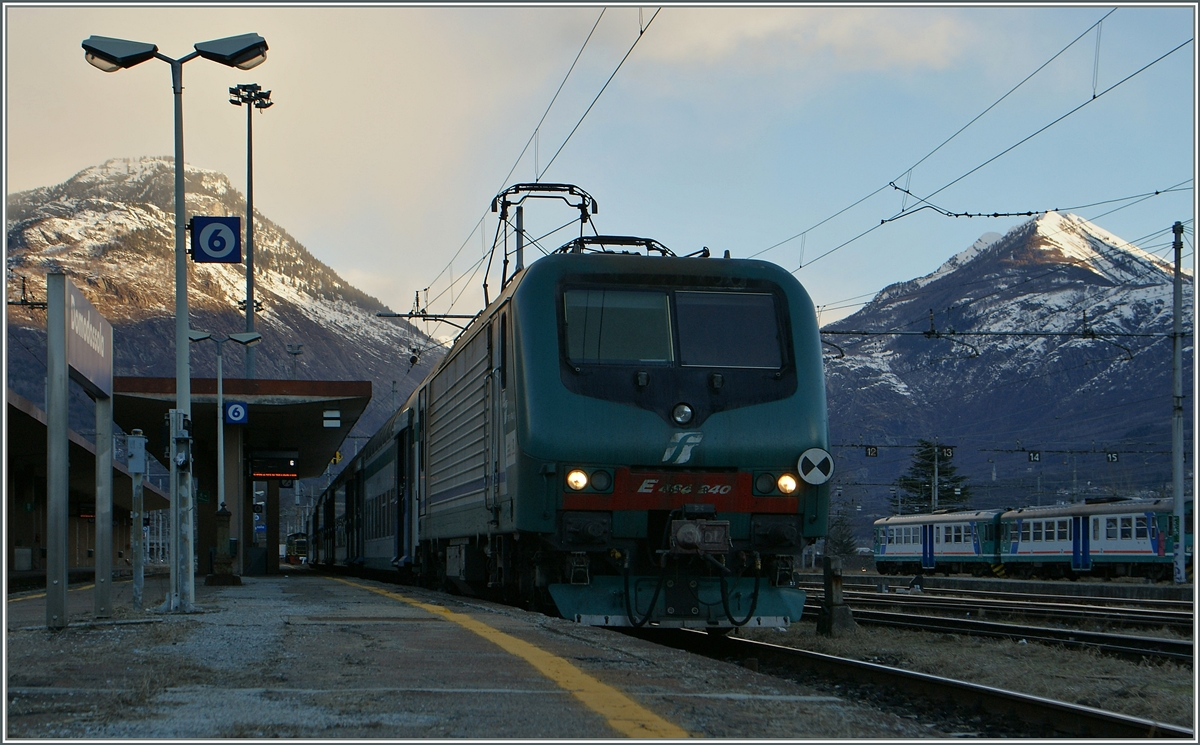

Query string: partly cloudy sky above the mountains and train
[4,4,1196,323]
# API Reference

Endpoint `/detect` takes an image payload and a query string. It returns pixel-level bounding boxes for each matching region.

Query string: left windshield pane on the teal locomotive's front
[563,289,674,364]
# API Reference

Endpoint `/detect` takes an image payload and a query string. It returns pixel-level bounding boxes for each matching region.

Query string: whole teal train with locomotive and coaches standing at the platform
[311,185,833,630]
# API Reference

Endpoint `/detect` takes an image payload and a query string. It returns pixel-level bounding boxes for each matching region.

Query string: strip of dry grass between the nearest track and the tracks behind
[738,624,1195,727]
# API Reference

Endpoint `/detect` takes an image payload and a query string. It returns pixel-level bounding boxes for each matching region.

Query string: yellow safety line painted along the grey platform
[334,577,689,739]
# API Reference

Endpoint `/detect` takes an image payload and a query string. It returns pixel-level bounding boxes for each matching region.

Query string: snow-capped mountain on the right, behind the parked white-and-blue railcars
[823,212,1193,506]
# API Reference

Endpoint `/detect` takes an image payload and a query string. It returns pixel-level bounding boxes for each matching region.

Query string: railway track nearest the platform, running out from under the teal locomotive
[653,631,1194,739]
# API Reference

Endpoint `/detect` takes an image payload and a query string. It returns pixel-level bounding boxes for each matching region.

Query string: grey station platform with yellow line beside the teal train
[5,566,929,740]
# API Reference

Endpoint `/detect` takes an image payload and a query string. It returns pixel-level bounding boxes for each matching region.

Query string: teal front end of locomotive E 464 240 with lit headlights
[472,253,833,629]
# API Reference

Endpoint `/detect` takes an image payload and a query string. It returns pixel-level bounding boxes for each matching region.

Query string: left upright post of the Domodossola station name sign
[46,274,71,631]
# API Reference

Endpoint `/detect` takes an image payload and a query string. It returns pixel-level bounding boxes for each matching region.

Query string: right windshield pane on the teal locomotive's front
[676,290,784,370]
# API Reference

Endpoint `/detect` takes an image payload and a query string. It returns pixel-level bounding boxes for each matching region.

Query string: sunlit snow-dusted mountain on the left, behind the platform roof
[5,157,440,434]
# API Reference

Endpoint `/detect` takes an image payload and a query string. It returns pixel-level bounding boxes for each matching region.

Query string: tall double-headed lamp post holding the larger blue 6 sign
[83,34,266,612]
